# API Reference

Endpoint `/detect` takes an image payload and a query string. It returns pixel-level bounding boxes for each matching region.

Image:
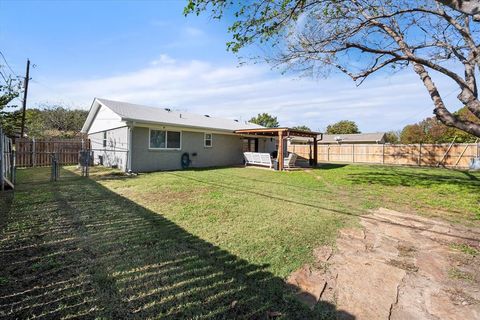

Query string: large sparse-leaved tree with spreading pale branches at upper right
[185,0,480,137]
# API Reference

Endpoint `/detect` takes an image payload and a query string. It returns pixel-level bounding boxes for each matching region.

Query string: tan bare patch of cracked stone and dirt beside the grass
[287,208,480,319]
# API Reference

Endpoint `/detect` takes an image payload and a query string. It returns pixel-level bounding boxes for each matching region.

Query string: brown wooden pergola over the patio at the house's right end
[235,128,321,171]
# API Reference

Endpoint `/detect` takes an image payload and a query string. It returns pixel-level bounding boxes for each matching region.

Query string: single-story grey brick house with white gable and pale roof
[82,98,278,172]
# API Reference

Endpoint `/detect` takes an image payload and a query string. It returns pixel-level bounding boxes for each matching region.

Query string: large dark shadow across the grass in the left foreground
[0,172,348,319]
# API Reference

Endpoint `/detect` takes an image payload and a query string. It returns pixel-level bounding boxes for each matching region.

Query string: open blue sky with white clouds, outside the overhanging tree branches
[0,0,464,132]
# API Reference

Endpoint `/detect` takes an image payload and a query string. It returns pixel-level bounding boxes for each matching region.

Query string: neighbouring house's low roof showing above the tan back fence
[289,132,386,144]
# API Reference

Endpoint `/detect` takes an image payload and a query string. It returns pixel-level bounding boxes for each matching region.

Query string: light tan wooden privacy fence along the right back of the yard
[288,143,480,168]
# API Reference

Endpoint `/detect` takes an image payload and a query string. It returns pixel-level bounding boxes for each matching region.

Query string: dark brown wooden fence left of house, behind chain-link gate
[15,139,90,167]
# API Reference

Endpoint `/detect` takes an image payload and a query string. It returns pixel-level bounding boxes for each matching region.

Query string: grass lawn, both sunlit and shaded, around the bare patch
[0,165,480,319]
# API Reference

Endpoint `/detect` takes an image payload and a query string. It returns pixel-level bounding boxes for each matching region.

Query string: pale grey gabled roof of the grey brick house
[82,98,263,132]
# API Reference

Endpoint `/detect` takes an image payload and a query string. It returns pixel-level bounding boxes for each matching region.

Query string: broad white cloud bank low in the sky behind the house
[30,55,458,131]
